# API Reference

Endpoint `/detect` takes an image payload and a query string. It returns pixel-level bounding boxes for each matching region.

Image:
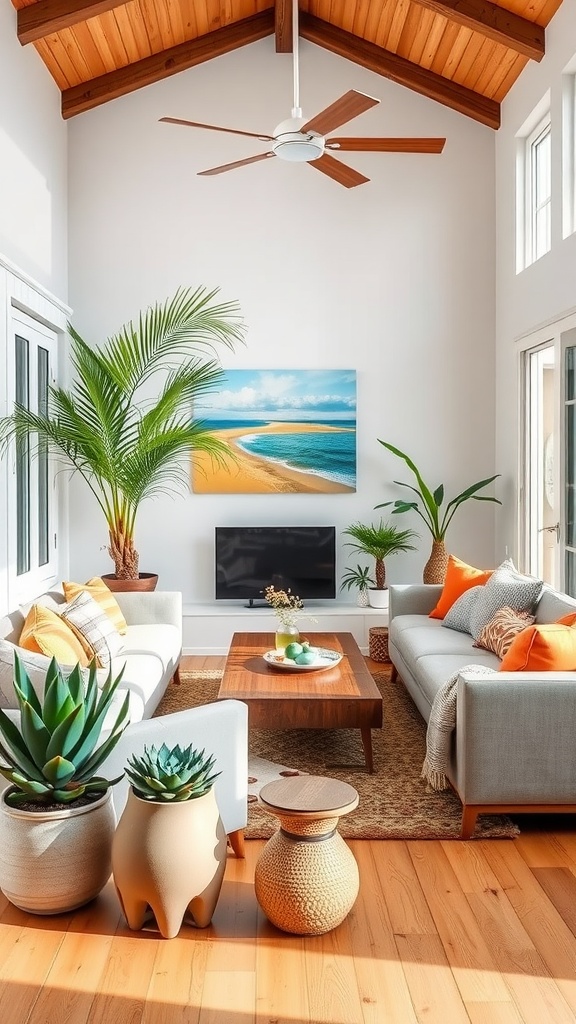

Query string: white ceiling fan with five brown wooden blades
[160,0,446,188]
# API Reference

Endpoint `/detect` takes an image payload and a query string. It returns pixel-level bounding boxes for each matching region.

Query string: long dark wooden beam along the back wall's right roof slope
[300,11,500,128]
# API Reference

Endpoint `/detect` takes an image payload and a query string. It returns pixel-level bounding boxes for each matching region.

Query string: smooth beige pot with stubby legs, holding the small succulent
[112,788,227,939]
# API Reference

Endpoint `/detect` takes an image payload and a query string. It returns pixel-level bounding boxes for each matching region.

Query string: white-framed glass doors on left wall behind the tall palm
[8,310,56,598]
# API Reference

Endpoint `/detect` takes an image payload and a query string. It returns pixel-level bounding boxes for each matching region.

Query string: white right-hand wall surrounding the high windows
[496,3,576,555]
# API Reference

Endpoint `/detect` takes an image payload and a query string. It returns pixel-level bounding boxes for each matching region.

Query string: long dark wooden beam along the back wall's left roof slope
[61,8,274,119]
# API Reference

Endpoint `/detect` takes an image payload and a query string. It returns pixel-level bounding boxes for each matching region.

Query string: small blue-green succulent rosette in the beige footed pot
[126,743,221,802]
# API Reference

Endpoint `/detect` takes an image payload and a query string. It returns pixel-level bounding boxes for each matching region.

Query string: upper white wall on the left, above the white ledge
[0,3,68,300]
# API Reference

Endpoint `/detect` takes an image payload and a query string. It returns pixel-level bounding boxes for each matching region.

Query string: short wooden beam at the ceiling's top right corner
[409,0,544,60]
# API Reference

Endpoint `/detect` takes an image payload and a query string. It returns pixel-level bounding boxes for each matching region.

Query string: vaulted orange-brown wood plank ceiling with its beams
[8,0,563,128]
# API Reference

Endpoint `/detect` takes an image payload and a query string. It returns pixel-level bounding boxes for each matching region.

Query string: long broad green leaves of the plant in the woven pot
[375,438,502,541]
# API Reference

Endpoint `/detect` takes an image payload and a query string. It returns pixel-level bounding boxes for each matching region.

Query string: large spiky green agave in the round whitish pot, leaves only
[0,654,129,807]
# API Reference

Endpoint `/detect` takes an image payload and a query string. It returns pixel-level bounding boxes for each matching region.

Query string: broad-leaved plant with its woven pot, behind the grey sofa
[375,438,502,584]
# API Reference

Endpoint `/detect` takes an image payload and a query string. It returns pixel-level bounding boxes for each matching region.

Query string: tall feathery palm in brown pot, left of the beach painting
[0,287,244,590]
